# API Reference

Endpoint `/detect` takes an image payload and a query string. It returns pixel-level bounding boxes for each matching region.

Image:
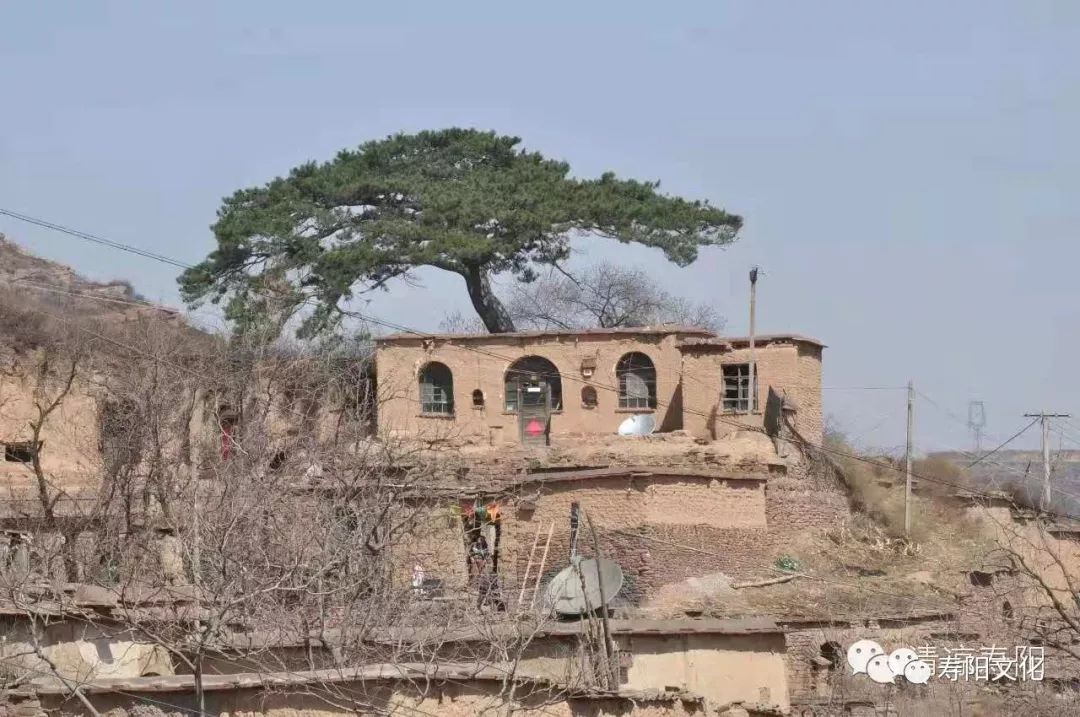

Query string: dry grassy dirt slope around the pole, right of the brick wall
[686,433,995,619]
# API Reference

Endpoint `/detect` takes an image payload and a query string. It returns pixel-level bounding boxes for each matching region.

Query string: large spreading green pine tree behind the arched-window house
[179,128,742,336]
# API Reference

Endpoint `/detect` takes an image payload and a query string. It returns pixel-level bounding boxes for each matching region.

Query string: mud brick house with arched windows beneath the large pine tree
[376,325,824,445]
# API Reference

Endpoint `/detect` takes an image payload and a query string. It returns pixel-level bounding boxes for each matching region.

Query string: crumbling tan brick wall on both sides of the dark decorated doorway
[393,471,774,604]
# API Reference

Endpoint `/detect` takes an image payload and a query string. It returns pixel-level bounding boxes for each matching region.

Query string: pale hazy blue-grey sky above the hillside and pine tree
[0,0,1080,450]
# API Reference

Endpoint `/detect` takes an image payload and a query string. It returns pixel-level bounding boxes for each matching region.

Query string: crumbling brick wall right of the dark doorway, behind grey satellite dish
[501,474,767,604]
